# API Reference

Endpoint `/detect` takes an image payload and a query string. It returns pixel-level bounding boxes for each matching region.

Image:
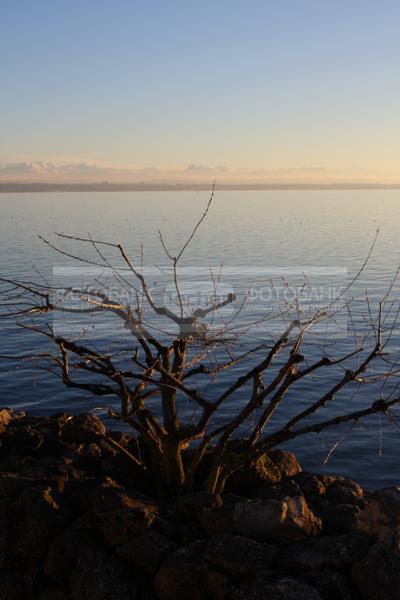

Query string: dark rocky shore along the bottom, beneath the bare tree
[0,409,400,600]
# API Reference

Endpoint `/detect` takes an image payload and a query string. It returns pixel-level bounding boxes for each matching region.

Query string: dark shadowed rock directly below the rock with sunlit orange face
[204,534,278,577]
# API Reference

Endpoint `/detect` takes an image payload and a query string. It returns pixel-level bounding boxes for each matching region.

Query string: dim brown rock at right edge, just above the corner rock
[356,487,400,539]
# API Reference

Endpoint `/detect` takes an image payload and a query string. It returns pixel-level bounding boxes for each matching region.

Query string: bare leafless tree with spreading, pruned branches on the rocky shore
[0,189,400,495]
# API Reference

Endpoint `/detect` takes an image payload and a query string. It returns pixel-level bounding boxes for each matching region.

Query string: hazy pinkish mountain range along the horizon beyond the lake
[0,161,400,192]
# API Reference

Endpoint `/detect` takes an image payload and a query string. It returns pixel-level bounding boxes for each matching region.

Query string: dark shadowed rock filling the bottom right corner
[352,531,400,600]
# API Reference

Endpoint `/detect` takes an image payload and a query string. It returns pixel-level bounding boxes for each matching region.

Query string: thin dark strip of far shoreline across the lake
[0,182,400,194]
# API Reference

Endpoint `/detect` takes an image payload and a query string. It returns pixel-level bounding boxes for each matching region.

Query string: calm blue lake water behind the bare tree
[0,191,400,487]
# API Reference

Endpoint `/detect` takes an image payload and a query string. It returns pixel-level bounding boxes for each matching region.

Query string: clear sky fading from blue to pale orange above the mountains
[0,0,400,181]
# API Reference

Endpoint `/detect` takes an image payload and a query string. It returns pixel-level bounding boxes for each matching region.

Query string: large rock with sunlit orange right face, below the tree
[200,496,321,541]
